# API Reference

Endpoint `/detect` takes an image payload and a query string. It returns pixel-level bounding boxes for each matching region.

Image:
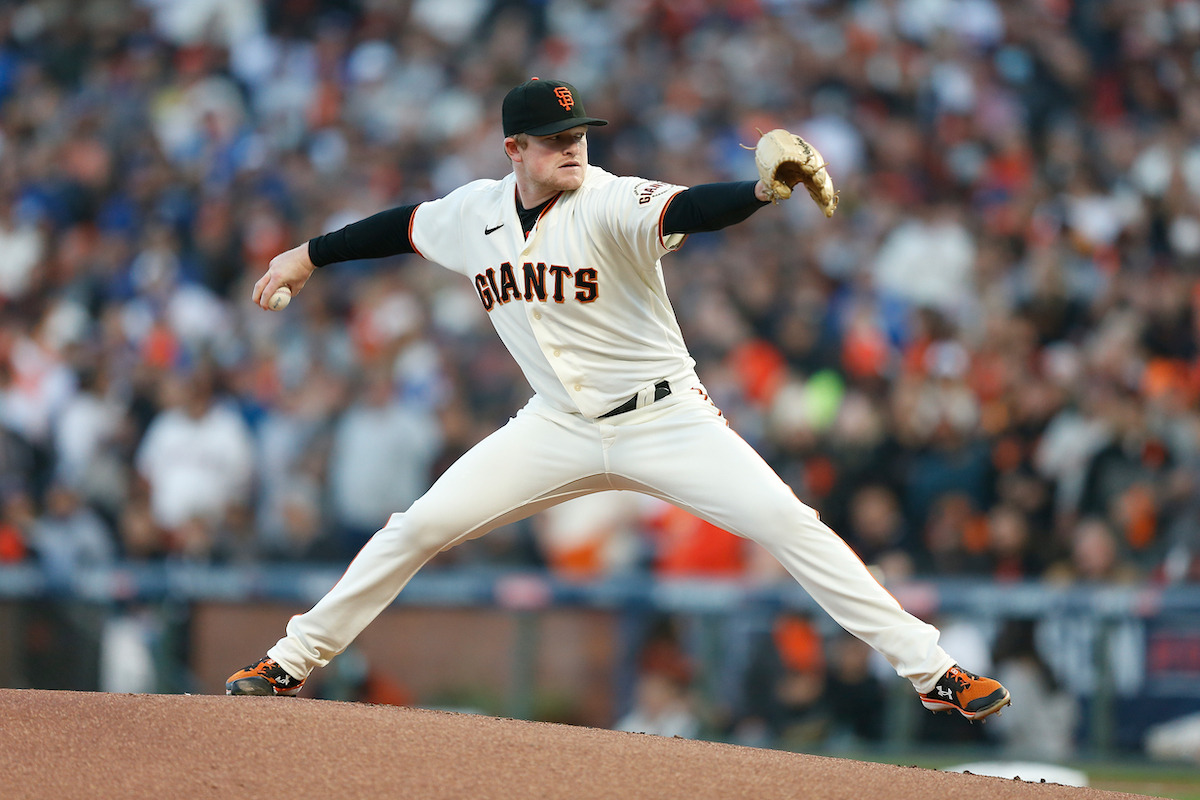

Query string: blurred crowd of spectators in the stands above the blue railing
[0,0,1200,583]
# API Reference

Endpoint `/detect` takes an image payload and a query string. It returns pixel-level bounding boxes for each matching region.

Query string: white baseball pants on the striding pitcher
[268,381,954,692]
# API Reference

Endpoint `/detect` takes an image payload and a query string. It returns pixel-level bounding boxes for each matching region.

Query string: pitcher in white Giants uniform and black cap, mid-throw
[226,78,1009,720]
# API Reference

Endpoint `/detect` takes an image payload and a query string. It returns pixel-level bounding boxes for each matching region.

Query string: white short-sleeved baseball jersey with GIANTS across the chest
[409,167,695,419]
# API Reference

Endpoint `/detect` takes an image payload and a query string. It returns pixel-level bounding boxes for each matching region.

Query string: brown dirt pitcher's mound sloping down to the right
[0,690,1161,800]
